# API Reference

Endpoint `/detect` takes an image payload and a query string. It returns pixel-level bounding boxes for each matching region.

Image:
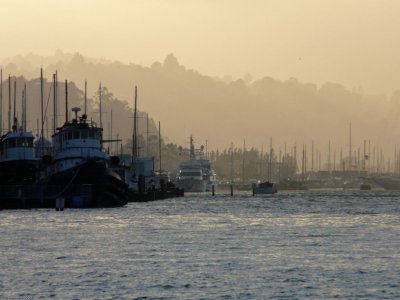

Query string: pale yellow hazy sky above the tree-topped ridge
[0,0,400,94]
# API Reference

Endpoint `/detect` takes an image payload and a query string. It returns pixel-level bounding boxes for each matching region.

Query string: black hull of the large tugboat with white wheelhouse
[45,161,127,208]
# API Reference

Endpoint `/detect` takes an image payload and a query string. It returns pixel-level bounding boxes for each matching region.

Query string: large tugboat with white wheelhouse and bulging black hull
[43,107,127,208]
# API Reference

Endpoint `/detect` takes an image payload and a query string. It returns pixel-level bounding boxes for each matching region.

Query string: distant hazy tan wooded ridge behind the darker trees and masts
[1,50,400,161]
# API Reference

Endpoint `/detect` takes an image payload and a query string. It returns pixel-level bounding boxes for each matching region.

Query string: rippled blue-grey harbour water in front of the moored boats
[0,191,400,299]
